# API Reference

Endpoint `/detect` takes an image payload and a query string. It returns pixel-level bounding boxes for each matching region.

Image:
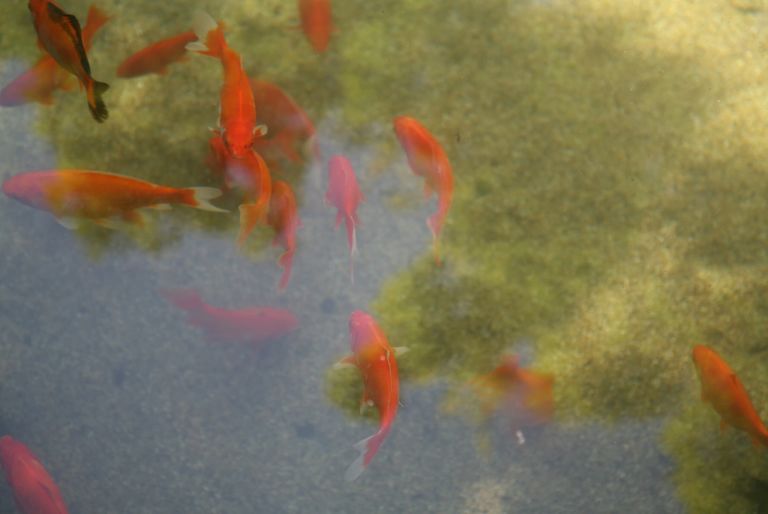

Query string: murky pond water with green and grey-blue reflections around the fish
[0,0,768,514]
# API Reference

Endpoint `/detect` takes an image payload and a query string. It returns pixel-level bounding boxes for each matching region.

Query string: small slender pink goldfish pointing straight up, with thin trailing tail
[325,155,365,278]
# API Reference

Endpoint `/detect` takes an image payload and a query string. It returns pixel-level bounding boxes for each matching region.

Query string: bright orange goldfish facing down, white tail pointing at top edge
[186,13,266,159]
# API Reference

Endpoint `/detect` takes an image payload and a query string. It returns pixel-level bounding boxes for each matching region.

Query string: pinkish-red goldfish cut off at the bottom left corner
[0,435,69,514]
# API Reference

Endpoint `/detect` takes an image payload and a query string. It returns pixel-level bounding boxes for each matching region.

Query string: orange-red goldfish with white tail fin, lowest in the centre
[338,310,405,480]
